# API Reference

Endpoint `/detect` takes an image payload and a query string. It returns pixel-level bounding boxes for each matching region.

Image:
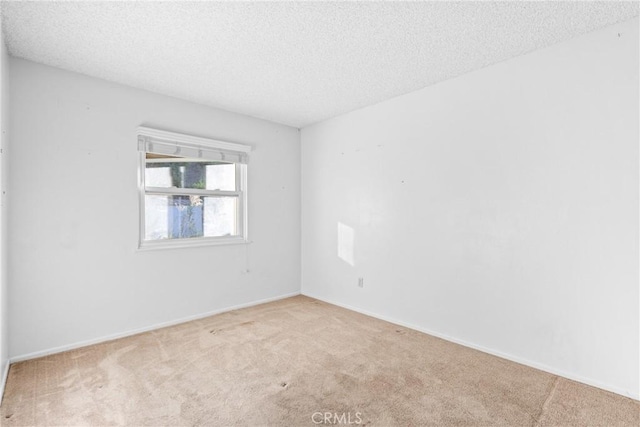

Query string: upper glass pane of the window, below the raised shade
[145,153,236,191]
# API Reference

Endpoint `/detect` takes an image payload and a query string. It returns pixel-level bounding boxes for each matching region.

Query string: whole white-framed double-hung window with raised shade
[138,127,251,248]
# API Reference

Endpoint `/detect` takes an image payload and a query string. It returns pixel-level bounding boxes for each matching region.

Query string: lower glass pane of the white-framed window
[145,195,238,240]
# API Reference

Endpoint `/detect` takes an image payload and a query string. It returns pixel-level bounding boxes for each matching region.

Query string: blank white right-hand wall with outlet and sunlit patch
[302,19,640,398]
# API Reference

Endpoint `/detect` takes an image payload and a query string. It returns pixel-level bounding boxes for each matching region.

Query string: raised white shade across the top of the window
[138,127,251,164]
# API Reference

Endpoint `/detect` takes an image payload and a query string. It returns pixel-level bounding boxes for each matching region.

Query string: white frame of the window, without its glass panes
[137,126,251,250]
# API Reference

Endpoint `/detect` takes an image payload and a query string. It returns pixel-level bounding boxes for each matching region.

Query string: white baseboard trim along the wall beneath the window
[7,292,300,365]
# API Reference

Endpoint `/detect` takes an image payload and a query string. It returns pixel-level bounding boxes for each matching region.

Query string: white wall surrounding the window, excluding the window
[9,58,300,358]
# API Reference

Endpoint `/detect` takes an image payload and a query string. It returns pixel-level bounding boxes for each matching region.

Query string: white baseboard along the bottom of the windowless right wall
[302,291,640,401]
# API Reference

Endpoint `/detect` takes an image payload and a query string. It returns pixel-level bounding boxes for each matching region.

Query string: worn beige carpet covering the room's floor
[0,296,640,427]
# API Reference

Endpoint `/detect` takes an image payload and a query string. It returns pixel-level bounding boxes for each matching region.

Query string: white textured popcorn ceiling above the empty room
[2,1,638,127]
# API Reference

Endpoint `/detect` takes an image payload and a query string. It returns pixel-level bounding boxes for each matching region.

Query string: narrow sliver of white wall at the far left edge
[0,10,9,400]
